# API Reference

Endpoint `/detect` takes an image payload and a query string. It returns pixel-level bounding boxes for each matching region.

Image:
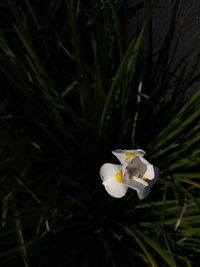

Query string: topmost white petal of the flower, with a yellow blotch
[112,149,145,164]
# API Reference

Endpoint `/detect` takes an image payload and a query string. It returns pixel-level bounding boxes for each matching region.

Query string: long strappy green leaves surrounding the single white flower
[0,0,200,267]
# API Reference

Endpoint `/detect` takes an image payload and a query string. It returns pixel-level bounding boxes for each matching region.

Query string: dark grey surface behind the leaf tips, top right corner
[126,0,200,94]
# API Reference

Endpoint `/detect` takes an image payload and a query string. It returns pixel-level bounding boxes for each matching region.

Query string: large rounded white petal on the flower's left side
[100,163,128,198]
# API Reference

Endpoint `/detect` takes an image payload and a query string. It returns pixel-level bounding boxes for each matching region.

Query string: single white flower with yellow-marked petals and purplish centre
[100,149,158,199]
